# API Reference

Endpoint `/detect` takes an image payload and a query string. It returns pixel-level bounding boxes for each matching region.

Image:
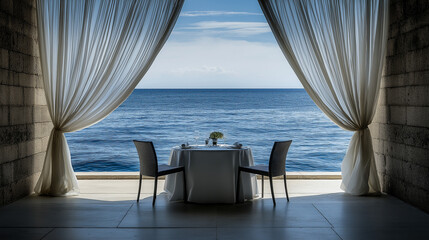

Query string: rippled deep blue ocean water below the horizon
[66,89,352,171]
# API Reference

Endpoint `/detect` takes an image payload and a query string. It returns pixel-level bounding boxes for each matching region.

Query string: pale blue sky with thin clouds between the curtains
[137,0,302,88]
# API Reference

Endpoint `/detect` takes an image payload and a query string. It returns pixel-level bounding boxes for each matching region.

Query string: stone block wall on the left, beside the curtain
[0,0,51,206]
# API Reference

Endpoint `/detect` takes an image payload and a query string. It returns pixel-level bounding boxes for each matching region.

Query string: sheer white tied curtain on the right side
[259,0,388,195]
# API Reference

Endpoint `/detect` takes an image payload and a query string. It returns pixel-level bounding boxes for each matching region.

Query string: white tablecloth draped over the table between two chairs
[164,146,258,203]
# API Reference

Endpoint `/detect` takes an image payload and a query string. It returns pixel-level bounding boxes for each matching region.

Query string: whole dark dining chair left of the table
[133,140,186,205]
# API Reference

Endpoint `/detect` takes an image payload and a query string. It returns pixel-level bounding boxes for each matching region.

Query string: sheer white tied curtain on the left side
[35,0,183,196]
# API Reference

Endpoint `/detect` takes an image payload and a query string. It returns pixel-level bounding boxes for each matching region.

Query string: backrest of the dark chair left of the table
[133,140,158,177]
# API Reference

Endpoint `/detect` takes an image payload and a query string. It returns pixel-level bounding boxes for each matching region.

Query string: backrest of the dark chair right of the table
[269,140,292,177]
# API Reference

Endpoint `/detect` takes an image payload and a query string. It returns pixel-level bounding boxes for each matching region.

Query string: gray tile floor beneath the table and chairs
[0,180,429,240]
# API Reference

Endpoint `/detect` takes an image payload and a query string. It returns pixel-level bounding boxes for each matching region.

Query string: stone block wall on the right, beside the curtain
[371,0,429,211]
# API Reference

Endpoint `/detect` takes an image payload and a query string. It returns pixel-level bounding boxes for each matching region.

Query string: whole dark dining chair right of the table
[236,140,292,205]
